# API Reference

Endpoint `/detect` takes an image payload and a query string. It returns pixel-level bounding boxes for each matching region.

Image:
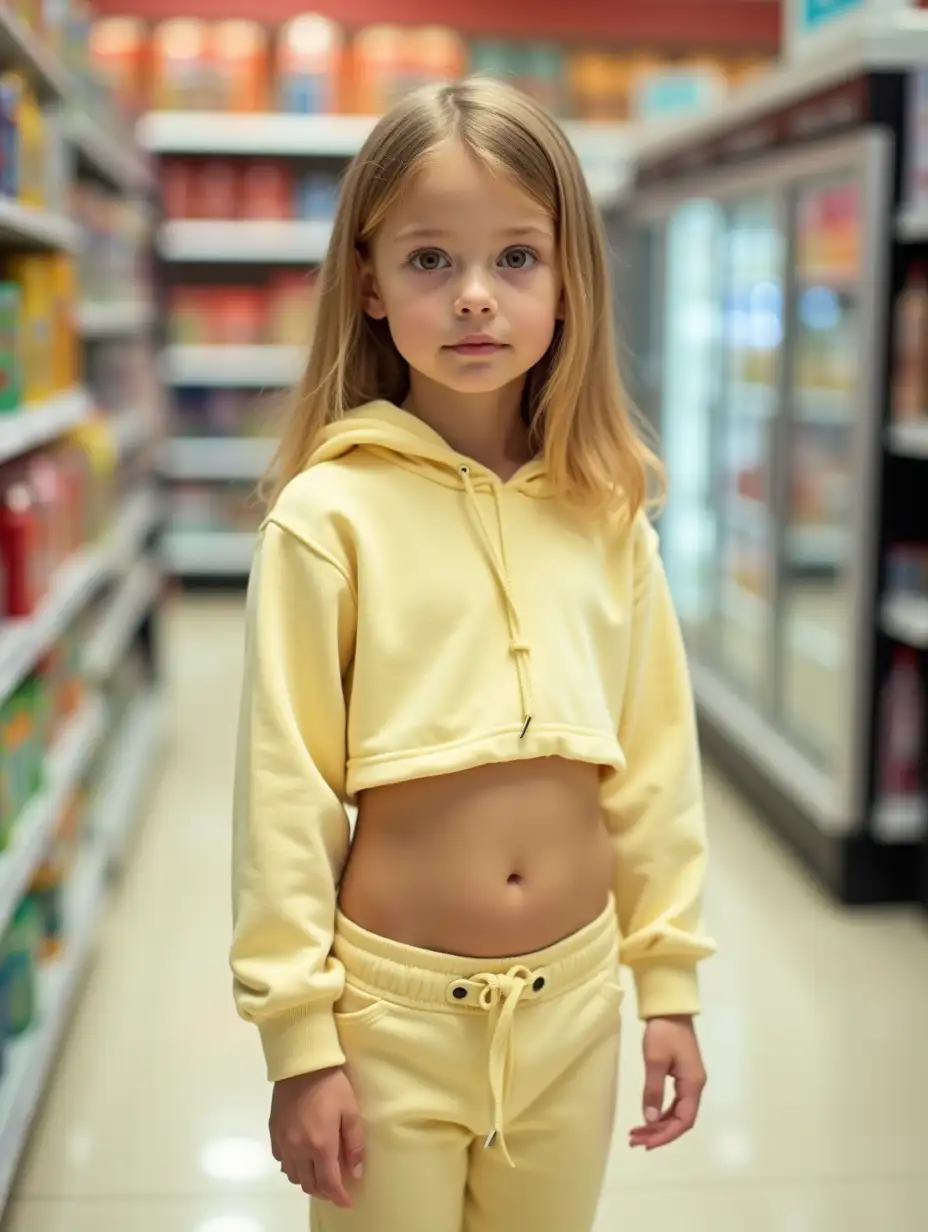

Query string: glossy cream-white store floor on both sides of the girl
[4,600,928,1232]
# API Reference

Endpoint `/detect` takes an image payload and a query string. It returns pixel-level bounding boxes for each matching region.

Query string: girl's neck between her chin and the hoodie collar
[404,372,532,479]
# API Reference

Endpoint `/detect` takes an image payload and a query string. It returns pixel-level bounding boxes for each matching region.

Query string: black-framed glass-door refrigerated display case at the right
[616,15,928,902]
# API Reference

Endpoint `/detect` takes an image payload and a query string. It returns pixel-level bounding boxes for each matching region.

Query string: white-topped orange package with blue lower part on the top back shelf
[275,14,345,116]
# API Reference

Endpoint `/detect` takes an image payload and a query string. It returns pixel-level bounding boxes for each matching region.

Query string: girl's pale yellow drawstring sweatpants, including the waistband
[312,904,621,1232]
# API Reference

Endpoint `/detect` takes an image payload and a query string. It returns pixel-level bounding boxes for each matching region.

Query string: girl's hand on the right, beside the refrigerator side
[629,1018,706,1151]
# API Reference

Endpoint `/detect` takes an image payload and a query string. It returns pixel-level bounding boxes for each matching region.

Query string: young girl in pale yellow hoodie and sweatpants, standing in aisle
[232,80,711,1232]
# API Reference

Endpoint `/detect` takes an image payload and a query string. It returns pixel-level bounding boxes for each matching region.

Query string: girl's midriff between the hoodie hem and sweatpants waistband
[339,758,613,958]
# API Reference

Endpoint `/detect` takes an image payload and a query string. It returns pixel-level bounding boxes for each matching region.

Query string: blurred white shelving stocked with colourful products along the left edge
[0,4,163,1206]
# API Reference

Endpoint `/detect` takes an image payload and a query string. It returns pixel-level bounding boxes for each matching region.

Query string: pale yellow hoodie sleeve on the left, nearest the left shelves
[230,521,356,1080]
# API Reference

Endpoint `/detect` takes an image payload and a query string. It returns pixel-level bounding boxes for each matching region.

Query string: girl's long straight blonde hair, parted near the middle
[263,78,663,517]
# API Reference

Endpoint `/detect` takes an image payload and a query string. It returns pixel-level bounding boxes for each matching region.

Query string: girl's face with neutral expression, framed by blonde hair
[361,143,561,393]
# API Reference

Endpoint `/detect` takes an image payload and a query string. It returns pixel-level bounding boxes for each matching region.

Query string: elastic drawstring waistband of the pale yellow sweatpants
[334,898,619,1009]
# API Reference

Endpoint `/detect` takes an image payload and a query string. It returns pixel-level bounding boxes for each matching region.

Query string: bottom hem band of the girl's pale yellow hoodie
[346,723,625,798]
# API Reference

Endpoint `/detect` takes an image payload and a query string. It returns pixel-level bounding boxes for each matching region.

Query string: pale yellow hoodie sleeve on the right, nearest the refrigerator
[604,516,715,1019]
